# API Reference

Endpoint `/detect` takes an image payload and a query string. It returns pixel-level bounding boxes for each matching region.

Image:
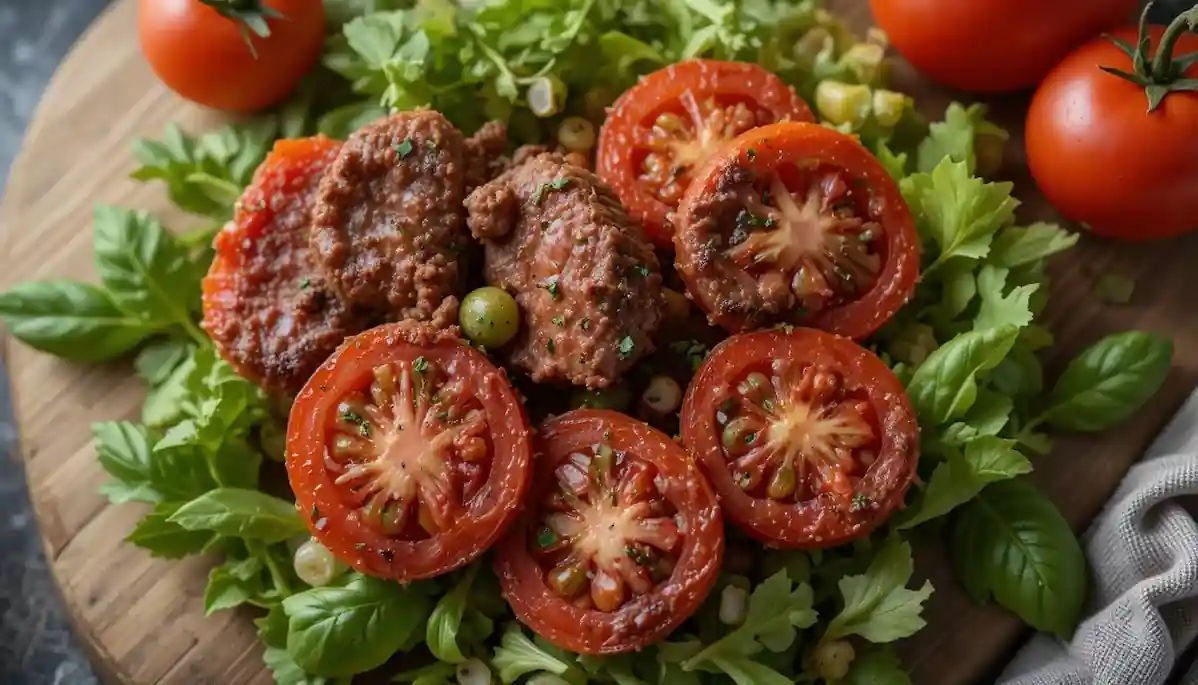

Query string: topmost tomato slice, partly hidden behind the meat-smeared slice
[597,60,815,249]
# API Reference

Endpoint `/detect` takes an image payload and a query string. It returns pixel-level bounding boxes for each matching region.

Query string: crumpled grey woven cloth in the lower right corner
[999,393,1198,685]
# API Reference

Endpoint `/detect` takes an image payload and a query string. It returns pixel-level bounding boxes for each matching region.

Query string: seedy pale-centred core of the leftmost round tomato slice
[326,357,491,541]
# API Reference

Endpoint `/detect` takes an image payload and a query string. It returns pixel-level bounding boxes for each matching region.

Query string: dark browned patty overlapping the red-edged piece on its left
[311,110,490,327]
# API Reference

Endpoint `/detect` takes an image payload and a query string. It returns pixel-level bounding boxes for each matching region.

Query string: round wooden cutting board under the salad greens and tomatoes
[0,0,1198,685]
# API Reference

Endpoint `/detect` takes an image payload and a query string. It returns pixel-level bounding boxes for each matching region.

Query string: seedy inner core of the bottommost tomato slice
[530,444,682,613]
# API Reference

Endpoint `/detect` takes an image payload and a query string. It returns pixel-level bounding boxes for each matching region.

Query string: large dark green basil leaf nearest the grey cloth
[950,479,1087,637]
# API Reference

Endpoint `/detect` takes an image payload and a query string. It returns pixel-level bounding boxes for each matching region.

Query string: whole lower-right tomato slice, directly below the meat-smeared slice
[682,328,919,548]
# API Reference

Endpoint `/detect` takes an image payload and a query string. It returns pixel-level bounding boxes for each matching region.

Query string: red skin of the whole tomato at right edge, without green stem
[1025,26,1198,241]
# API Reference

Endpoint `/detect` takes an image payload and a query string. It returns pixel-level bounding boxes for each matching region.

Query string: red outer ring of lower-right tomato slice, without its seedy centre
[682,328,919,550]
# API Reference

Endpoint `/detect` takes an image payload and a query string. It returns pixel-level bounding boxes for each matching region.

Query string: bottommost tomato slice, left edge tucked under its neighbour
[495,410,724,654]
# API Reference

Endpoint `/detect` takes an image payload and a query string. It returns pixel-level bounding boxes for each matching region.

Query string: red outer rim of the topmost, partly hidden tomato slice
[595,60,815,250]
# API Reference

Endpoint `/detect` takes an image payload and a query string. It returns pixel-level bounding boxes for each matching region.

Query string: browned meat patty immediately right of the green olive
[466,154,662,388]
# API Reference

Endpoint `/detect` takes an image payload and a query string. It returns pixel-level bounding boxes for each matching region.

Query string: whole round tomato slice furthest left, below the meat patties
[286,322,532,581]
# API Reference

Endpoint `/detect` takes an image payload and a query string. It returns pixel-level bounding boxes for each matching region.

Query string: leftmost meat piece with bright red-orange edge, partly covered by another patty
[202,138,369,394]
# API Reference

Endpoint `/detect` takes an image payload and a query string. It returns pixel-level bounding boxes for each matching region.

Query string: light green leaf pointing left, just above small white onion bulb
[170,487,308,542]
